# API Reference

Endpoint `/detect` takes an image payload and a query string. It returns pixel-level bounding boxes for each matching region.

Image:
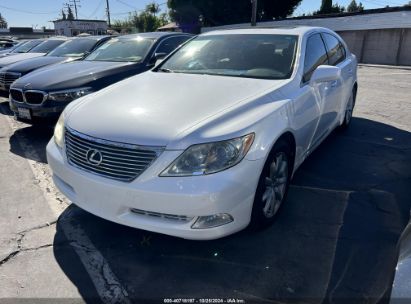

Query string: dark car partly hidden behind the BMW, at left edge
[0,36,111,91]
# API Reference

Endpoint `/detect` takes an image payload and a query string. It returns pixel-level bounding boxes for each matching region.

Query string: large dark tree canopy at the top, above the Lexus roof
[167,0,301,26]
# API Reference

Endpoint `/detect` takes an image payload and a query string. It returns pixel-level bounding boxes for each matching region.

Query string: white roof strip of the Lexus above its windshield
[202,26,329,36]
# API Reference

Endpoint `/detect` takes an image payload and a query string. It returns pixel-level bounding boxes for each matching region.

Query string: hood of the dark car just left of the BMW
[3,56,76,74]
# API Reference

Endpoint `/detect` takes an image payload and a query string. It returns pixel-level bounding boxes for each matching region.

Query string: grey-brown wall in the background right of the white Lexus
[338,29,411,65]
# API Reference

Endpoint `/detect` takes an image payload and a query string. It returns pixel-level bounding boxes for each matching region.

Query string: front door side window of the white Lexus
[303,34,328,82]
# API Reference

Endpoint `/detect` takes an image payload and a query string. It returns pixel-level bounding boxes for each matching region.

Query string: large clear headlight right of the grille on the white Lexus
[160,133,254,176]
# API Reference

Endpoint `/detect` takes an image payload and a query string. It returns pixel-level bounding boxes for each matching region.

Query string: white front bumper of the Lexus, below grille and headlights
[47,139,264,240]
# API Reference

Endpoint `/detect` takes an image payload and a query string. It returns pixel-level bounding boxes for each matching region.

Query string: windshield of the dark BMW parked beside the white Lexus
[85,37,154,62]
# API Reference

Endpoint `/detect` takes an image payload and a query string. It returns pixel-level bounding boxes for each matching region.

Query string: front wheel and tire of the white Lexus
[250,141,294,230]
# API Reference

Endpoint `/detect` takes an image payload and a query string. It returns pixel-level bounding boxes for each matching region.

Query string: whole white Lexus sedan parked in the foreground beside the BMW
[47,27,357,240]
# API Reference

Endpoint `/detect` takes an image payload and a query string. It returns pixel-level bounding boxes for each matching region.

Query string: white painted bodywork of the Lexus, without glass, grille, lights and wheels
[47,27,357,239]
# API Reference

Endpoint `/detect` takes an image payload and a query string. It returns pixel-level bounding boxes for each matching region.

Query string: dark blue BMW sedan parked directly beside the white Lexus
[10,32,192,123]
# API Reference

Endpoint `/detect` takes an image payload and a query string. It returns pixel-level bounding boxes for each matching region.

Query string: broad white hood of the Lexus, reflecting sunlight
[65,71,286,149]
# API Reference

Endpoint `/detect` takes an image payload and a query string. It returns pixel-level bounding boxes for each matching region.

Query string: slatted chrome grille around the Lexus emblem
[65,128,163,182]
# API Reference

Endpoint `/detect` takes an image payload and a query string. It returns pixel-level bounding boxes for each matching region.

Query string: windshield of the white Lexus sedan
[158,34,298,79]
